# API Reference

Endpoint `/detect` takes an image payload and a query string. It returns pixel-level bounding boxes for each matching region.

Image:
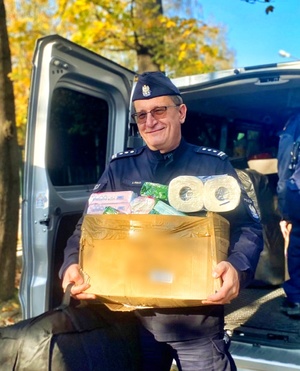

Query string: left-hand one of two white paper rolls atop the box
[168,175,204,213]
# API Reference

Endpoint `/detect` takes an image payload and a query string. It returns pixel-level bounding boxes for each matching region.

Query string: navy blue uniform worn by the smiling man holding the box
[61,140,263,370]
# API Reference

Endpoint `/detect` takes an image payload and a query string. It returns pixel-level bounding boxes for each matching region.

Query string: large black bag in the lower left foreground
[0,286,141,371]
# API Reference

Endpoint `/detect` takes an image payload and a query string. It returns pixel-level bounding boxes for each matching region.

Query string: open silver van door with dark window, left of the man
[20,35,134,318]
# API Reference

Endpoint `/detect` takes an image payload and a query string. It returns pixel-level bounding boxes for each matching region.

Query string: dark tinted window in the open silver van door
[46,88,108,186]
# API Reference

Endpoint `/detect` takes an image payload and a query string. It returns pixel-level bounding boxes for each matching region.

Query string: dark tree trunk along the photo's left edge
[0,0,20,300]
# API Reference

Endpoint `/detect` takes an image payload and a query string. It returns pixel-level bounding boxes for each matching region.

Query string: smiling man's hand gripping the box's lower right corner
[202,261,240,304]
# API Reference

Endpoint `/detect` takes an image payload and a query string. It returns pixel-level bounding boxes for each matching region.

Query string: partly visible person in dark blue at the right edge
[277,114,300,318]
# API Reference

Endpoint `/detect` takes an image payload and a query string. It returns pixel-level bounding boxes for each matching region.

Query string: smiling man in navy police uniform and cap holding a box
[61,72,263,371]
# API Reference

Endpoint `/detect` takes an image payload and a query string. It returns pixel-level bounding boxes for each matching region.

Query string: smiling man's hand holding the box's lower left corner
[62,264,96,300]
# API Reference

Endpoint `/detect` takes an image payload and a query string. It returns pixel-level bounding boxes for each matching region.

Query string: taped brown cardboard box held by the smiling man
[80,213,229,310]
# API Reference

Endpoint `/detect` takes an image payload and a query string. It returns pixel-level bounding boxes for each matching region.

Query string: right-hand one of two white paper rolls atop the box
[203,175,241,212]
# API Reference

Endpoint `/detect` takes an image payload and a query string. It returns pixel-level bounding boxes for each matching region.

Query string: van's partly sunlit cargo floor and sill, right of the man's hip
[225,287,300,349]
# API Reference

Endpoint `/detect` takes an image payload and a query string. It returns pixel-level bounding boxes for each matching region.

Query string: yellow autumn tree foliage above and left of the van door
[5,0,234,145]
